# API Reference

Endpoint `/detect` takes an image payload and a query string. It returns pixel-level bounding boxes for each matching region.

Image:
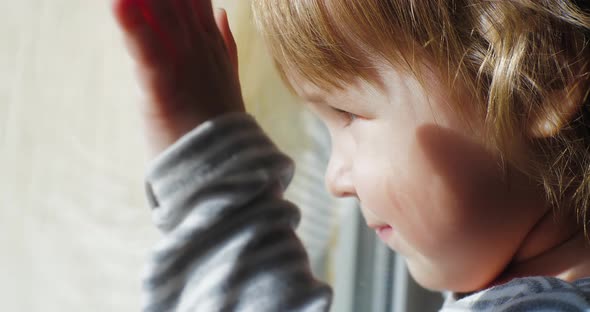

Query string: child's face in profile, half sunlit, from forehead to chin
[292,69,545,291]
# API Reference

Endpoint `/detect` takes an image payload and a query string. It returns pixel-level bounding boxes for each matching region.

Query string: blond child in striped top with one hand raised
[115,0,590,311]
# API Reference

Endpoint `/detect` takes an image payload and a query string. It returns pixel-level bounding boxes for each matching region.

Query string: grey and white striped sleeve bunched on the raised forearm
[142,113,332,312]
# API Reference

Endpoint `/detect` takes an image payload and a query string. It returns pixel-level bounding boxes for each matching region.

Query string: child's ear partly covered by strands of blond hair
[529,83,587,138]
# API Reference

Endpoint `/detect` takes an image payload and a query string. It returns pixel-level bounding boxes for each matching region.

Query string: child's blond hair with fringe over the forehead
[252,0,590,230]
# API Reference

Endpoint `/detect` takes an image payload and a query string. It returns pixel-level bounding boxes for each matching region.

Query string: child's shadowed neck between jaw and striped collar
[490,210,590,286]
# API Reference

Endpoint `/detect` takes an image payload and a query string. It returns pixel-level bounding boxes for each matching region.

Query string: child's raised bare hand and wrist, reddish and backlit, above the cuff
[113,0,244,156]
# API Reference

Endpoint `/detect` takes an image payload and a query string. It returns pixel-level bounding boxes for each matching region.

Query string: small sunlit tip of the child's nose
[325,155,356,197]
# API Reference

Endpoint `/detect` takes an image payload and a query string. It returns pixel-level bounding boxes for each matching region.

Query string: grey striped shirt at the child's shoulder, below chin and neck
[440,276,590,312]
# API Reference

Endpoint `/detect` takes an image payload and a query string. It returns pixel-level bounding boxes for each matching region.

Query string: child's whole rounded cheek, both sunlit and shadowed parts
[355,121,526,290]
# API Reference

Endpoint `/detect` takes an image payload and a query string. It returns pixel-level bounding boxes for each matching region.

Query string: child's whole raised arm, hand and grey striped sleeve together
[114,0,332,312]
